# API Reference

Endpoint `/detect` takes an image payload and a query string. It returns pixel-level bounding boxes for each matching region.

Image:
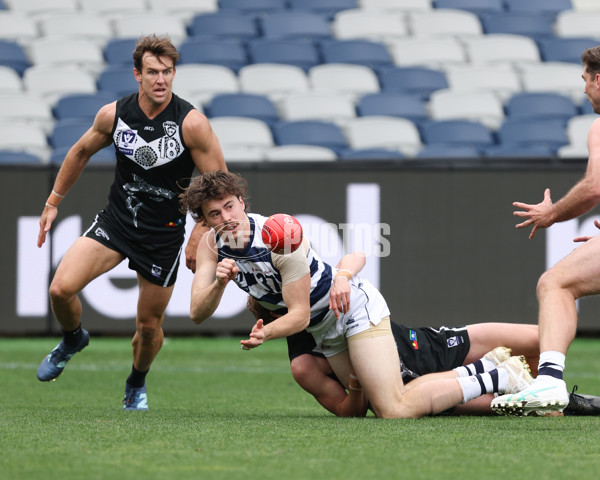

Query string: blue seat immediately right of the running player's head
[179,37,248,72]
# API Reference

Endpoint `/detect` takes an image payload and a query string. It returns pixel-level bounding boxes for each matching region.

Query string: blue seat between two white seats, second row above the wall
[273,120,348,153]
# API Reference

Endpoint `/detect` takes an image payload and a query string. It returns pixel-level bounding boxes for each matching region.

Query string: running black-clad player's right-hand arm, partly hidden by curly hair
[181,110,227,272]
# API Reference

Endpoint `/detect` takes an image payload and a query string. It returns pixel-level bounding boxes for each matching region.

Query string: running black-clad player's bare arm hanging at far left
[37,102,116,247]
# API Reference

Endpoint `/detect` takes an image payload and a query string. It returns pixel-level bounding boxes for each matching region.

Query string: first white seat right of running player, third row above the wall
[281,92,356,125]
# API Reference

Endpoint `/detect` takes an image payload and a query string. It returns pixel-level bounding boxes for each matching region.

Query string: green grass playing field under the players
[0,338,600,480]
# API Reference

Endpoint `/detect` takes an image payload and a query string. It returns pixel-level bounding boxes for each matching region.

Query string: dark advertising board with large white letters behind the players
[0,162,600,335]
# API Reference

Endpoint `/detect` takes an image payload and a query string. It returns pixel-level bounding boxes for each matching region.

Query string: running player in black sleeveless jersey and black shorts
[37,35,226,410]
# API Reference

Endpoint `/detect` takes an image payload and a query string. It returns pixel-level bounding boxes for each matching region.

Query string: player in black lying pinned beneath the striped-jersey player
[248,288,600,417]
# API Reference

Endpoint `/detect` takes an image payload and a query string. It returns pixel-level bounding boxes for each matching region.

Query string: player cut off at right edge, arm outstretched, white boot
[492,47,600,415]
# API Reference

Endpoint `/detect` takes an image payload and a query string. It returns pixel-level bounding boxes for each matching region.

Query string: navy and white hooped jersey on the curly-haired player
[215,213,333,327]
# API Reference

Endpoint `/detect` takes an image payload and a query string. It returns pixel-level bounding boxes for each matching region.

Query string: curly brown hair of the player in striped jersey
[179,170,249,221]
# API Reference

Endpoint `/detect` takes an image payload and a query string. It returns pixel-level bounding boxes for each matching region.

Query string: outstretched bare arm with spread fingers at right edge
[513,120,600,239]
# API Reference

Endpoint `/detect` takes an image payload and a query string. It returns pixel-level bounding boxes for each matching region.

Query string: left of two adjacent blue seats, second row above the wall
[421,120,495,149]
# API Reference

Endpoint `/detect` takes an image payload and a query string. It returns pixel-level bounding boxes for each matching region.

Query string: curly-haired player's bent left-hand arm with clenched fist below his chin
[190,231,238,323]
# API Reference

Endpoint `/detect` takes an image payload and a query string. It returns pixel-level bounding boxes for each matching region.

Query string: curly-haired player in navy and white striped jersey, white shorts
[180,171,533,418]
